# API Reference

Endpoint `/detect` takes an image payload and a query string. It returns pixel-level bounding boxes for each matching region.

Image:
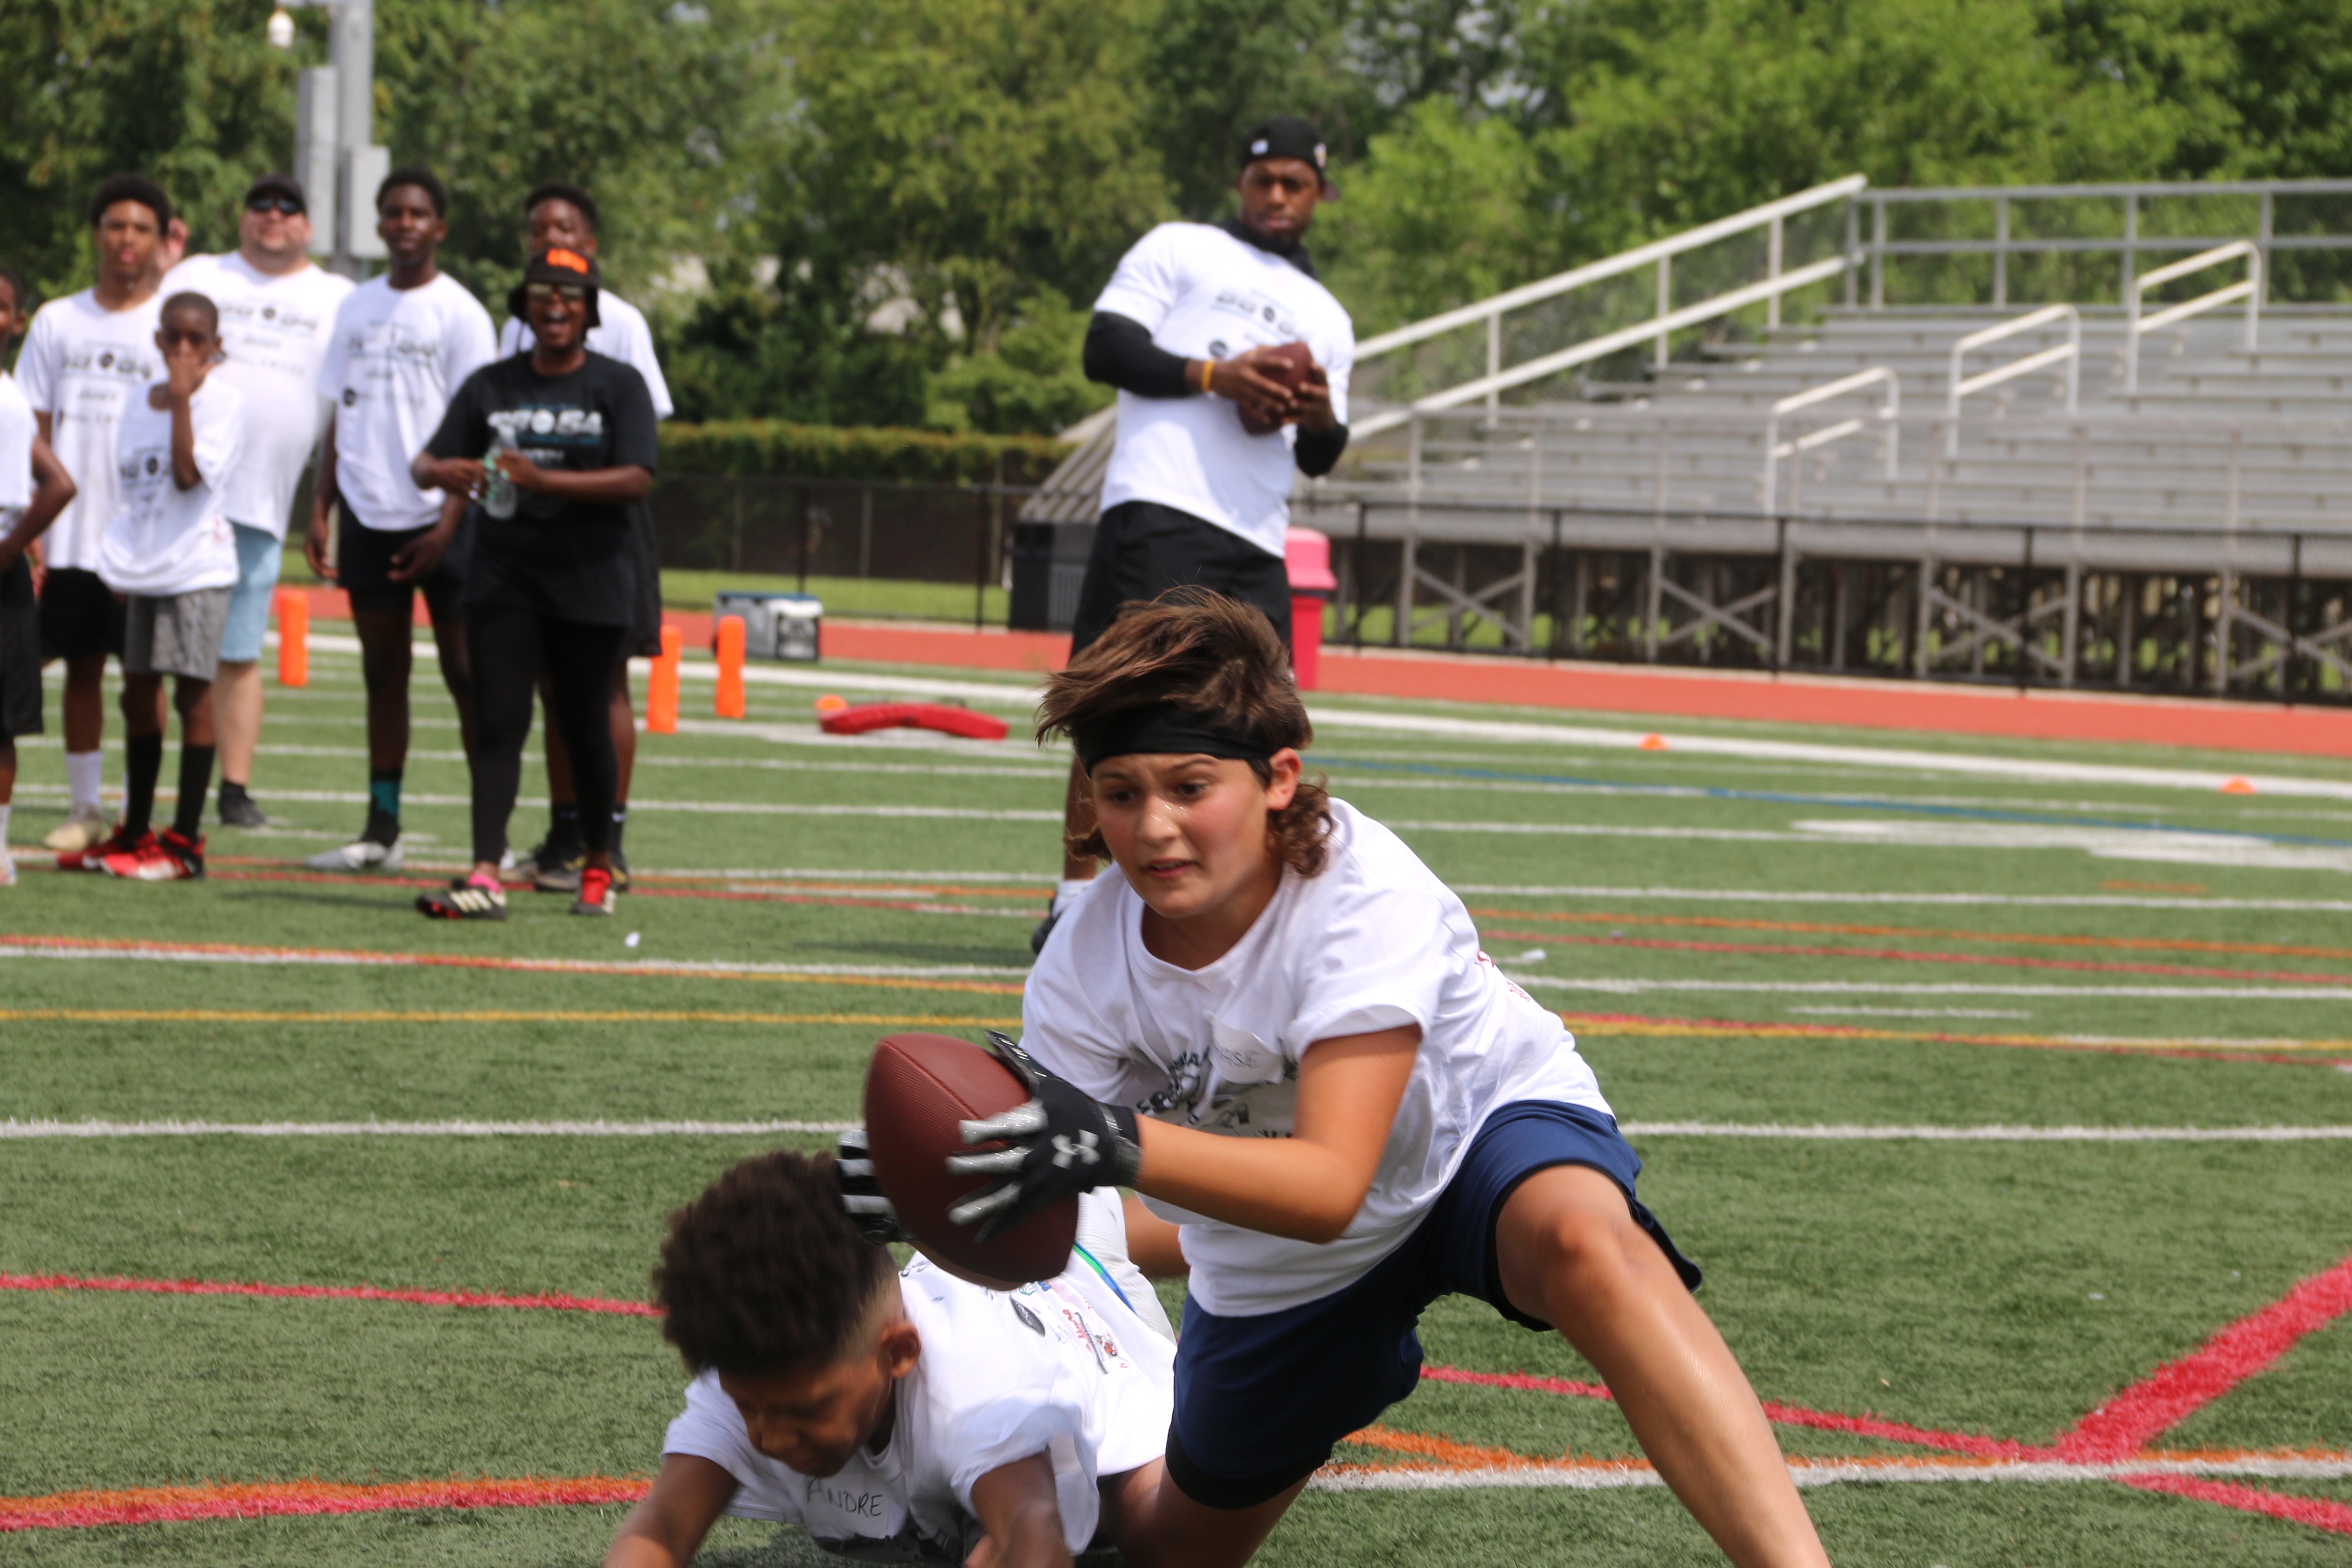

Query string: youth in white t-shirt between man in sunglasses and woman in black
[303,167,499,872]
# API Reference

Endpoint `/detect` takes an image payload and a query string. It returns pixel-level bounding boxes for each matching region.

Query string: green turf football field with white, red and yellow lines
[0,640,2352,1568]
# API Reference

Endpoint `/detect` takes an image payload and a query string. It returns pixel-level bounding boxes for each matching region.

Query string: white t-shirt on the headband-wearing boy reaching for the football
[1021,802,1609,1317]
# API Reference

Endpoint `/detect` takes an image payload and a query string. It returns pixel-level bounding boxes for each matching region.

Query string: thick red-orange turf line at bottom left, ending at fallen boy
[0,1476,652,1530]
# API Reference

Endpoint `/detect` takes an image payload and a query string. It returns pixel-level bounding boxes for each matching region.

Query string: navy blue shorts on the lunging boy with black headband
[1167,1100,1698,1509]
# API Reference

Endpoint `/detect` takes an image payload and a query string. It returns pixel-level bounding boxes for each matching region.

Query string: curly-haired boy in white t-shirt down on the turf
[604,1152,1176,1568]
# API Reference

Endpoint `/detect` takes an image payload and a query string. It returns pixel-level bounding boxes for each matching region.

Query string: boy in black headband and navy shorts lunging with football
[948,588,1828,1568]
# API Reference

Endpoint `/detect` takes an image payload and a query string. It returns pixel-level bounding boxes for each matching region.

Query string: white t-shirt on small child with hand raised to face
[99,376,245,600]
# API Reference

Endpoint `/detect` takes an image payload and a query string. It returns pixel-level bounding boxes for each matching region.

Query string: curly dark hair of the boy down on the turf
[654,1149,896,1375]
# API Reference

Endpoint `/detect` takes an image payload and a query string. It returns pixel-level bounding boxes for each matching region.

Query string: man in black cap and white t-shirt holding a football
[1030,120,1355,950]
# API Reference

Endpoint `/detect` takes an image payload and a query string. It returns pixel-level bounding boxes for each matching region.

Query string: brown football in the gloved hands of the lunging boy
[866,1034,1077,1291]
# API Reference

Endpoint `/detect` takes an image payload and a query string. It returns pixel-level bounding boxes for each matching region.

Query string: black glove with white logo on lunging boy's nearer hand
[948,1030,1143,1241]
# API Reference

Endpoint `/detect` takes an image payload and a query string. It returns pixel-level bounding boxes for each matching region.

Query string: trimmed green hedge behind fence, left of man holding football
[661,419,1070,484]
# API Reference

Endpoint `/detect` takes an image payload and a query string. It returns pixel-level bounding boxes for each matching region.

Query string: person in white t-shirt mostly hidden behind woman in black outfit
[499,181,673,893]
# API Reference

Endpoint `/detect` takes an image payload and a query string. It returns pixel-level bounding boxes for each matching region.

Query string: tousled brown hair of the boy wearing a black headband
[1037,585,1331,877]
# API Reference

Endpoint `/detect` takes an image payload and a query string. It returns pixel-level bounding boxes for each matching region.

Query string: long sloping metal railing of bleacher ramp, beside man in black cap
[1355,174,1870,437]
